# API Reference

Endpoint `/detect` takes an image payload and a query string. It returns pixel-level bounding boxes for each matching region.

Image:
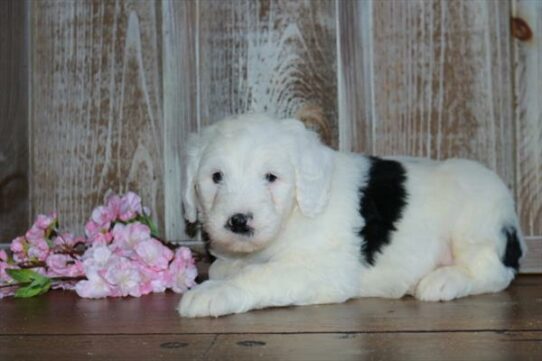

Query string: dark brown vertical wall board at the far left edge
[0,0,29,243]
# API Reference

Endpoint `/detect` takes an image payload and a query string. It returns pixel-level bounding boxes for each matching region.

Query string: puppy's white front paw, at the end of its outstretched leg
[178,281,250,317]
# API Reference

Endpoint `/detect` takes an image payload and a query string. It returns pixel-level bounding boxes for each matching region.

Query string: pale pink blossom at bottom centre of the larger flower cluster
[103,257,141,297]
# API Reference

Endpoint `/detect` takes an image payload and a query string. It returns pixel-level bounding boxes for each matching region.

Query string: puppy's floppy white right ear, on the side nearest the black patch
[284,119,335,217]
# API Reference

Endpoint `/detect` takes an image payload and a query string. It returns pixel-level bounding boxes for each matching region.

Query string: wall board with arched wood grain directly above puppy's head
[199,0,337,146]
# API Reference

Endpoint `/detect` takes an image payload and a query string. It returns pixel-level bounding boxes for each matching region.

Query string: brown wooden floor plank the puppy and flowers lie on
[0,275,542,335]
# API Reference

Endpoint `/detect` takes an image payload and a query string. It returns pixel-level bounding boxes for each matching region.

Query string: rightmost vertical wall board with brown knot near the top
[512,0,542,239]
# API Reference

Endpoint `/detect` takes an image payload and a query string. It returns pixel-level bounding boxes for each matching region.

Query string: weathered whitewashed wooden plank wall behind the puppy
[0,0,542,271]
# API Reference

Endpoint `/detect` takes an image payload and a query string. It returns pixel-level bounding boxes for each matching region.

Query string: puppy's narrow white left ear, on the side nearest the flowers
[182,133,203,223]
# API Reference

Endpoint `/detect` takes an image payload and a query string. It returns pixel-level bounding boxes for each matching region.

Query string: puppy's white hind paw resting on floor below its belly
[416,266,471,301]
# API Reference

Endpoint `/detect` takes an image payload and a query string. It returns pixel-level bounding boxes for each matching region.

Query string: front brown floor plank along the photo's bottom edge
[0,332,542,361]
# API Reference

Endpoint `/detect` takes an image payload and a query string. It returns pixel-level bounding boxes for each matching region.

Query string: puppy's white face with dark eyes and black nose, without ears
[196,136,295,253]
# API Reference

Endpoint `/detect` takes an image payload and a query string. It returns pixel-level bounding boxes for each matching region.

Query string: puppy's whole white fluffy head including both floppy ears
[183,114,333,253]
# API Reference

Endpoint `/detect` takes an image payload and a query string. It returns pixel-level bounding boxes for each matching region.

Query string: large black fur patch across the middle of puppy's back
[358,157,407,265]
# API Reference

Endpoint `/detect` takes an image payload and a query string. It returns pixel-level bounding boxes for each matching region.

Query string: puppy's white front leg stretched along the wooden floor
[179,262,355,317]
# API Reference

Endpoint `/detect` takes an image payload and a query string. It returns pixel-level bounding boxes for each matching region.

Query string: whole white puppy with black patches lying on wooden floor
[179,114,525,317]
